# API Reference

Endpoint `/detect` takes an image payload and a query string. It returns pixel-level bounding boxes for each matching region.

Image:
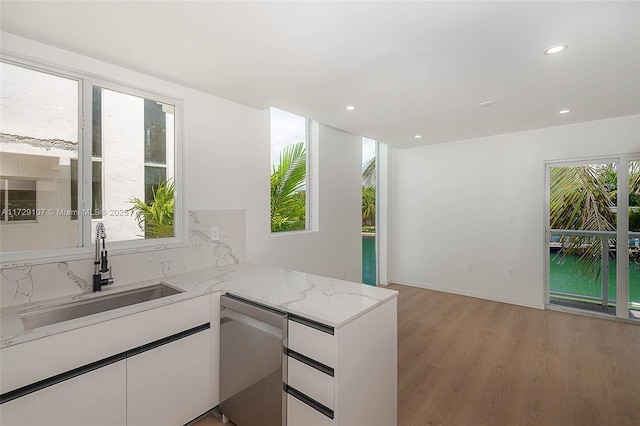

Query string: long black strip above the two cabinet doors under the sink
[0,323,211,404]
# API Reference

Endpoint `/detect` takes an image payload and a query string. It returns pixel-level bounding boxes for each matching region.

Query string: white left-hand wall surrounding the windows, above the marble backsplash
[0,33,361,281]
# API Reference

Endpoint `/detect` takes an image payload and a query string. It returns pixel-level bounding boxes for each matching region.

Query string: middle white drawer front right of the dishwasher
[287,356,335,410]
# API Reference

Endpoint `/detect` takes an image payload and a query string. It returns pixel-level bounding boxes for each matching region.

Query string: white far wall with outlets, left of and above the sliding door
[389,116,640,307]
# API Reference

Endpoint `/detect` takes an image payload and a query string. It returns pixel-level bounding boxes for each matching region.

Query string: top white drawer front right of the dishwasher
[288,320,335,367]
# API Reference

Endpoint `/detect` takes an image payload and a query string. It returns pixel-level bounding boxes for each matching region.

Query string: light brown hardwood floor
[196,284,640,426]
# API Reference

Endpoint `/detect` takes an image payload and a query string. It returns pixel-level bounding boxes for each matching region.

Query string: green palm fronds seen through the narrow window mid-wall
[271,142,307,232]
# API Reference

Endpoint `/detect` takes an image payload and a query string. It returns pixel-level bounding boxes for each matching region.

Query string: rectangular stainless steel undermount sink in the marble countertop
[19,284,182,330]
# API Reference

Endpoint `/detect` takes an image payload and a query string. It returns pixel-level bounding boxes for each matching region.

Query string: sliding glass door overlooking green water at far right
[545,157,640,319]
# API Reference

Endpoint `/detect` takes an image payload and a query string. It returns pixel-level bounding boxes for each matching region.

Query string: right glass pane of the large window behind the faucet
[91,86,175,241]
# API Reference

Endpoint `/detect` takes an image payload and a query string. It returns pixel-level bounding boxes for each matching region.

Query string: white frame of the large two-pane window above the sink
[0,54,187,268]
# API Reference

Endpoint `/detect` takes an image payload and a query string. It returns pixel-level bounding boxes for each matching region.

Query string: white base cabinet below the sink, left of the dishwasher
[0,293,219,426]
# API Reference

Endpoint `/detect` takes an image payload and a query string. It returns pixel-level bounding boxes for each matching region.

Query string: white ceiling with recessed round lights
[0,1,640,147]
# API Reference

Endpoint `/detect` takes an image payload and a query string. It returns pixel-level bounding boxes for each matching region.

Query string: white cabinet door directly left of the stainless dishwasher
[127,329,212,426]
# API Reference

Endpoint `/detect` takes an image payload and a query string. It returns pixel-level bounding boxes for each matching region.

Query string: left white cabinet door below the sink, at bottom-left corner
[0,360,127,426]
